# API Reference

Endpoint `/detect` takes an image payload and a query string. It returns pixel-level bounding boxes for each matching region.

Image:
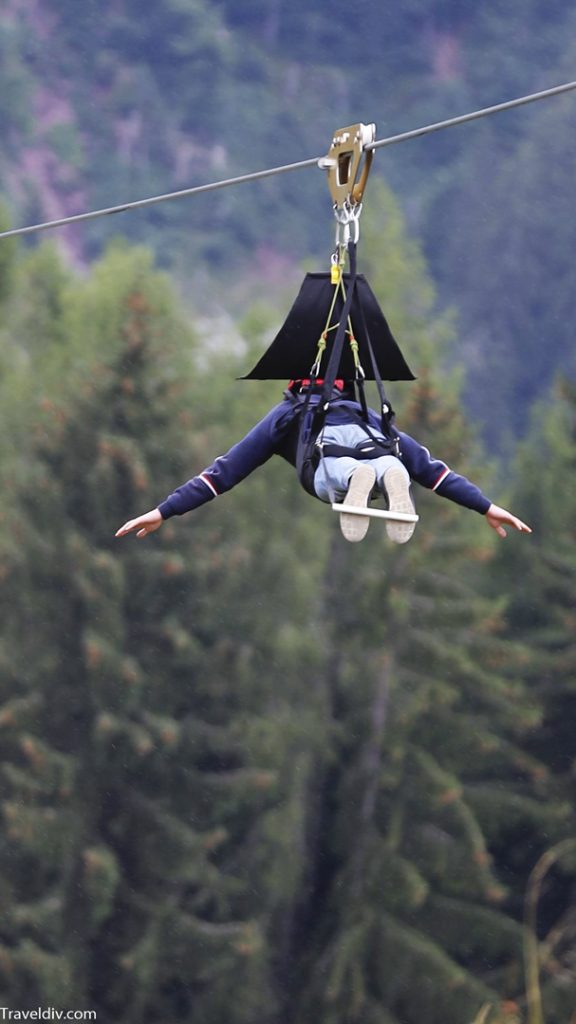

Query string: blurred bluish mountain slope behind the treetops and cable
[0,0,576,443]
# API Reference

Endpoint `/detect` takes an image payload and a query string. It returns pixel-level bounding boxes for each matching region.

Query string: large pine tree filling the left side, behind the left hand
[0,243,322,1024]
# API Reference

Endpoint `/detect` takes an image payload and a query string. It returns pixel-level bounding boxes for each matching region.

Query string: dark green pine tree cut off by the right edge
[485,382,576,1024]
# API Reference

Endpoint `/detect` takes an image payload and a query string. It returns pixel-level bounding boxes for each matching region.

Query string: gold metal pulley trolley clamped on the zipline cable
[319,124,376,207]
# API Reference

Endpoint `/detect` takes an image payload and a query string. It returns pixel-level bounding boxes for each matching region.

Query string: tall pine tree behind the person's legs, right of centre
[278,184,557,1024]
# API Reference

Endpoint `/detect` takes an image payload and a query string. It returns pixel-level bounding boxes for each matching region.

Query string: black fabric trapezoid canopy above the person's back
[240,273,415,381]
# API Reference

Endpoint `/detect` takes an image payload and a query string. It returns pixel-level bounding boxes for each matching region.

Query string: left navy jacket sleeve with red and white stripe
[158,402,292,519]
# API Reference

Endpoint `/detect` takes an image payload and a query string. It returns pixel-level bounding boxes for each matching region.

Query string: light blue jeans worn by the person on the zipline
[314,423,410,503]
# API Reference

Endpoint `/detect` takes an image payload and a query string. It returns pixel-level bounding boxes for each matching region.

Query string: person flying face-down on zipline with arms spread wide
[116,381,532,544]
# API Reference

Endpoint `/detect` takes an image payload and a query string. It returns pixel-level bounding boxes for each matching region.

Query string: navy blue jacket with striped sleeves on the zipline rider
[159,396,491,519]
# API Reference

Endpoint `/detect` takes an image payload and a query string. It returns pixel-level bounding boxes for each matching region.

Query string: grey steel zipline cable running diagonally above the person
[0,82,576,239]
